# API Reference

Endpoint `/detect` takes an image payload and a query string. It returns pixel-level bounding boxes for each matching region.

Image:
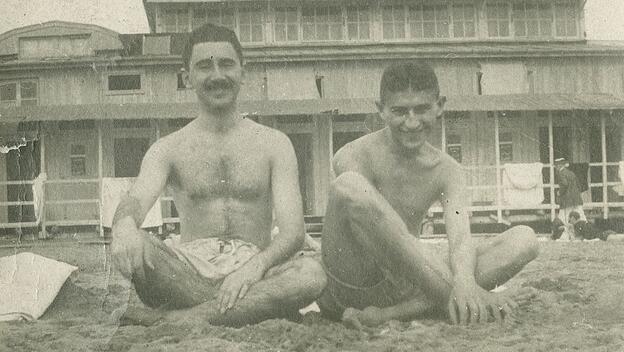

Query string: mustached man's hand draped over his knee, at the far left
[111,224,149,280]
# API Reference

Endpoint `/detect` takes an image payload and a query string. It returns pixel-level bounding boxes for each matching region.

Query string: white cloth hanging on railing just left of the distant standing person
[502,163,544,207]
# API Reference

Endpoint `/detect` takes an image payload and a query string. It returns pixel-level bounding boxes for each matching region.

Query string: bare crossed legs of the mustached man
[122,233,326,326]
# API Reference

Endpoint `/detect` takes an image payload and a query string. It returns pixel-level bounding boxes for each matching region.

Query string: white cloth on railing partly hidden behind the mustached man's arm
[101,177,163,227]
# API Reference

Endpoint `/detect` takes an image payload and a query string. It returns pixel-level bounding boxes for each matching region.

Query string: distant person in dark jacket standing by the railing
[555,158,586,224]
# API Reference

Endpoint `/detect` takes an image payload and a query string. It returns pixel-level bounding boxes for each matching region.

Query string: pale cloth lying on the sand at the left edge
[0,253,78,321]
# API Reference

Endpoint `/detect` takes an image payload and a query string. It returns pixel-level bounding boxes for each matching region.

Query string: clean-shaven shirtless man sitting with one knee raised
[318,63,538,327]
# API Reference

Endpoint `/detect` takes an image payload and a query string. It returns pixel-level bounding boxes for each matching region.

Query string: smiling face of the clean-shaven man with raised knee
[378,88,444,152]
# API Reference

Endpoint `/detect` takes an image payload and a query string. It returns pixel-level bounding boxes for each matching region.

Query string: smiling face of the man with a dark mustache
[187,42,243,109]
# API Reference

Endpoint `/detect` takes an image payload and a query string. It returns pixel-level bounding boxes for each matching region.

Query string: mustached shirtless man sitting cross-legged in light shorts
[112,24,325,326]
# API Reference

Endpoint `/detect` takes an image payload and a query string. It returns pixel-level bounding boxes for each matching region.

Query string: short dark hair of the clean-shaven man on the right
[379,62,440,104]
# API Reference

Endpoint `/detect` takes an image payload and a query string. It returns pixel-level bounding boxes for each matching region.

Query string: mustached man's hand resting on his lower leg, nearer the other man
[217,258,266,314]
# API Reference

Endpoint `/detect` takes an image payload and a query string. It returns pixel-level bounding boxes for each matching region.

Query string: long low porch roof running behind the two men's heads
[0,94,624,122]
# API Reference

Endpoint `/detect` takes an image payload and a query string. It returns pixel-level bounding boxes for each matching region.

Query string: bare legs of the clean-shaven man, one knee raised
[319,172,538,325]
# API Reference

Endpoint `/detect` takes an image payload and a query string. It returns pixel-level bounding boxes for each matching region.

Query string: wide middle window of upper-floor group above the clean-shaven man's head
[409,4,450,38]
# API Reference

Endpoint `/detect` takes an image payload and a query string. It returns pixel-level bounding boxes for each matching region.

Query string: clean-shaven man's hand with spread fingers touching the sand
[448,282,518,325]
